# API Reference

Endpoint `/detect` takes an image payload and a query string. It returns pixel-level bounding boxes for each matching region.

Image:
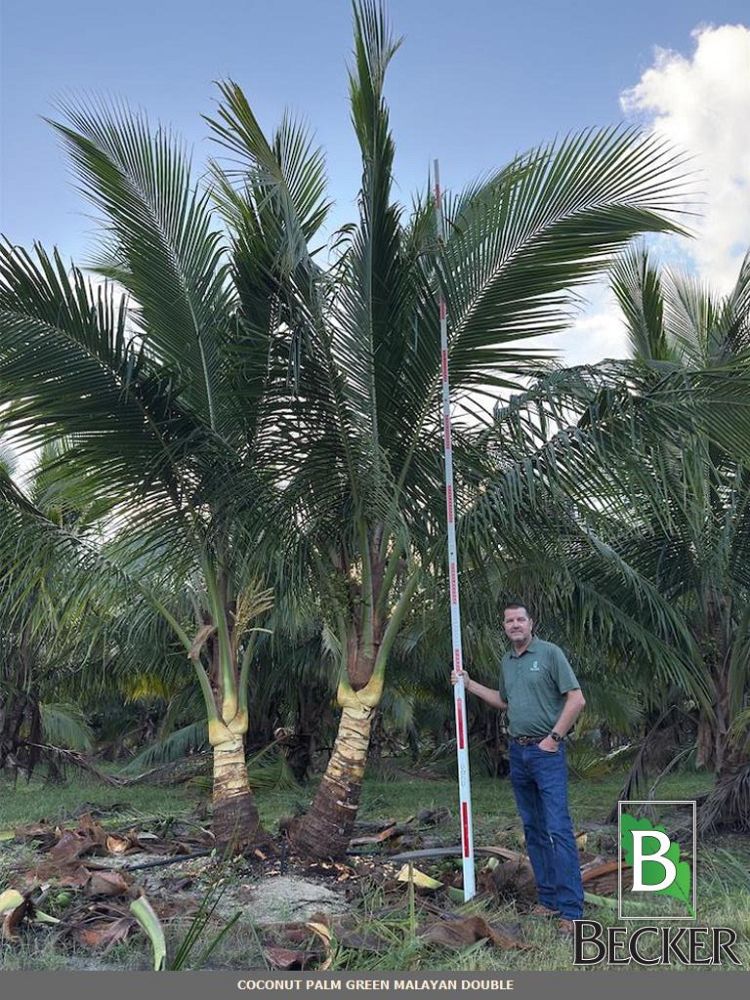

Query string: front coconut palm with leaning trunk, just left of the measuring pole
[197,0,708,854]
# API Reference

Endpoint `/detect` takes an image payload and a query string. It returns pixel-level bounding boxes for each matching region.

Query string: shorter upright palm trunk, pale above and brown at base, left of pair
[211,727,261,853]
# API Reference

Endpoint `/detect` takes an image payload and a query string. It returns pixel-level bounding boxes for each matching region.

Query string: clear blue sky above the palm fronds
[0,0,750,266]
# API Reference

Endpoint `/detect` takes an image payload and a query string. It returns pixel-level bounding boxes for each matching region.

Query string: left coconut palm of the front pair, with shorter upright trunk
[0,97,286,846]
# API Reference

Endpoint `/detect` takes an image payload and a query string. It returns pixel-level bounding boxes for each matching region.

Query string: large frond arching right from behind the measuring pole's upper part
[441,128,685,387]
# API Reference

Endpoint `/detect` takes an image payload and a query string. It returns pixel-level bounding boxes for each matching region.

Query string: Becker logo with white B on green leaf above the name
[573,800,742,966]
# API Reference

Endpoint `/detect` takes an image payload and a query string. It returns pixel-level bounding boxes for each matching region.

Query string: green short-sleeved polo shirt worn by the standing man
[498,636,581,737]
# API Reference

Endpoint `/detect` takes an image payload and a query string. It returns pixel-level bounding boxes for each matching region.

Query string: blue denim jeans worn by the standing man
[510,741,583,920]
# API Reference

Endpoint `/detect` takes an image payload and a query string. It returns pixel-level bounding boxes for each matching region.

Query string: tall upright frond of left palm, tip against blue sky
[51,96,233,433]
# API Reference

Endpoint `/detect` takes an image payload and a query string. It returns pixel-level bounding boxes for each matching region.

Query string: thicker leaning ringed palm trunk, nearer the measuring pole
[292,678,382,858]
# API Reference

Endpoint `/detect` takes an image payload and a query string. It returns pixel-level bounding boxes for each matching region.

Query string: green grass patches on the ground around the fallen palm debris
[0,760,750,973]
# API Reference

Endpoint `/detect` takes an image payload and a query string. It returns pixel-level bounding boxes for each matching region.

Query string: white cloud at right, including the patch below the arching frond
[560,25,750,372]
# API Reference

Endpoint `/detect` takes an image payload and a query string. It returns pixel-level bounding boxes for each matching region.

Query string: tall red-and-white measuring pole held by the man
[435,160,476,901]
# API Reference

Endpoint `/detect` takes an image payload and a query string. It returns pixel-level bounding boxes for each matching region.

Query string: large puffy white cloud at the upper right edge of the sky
[621,24,750,292]
